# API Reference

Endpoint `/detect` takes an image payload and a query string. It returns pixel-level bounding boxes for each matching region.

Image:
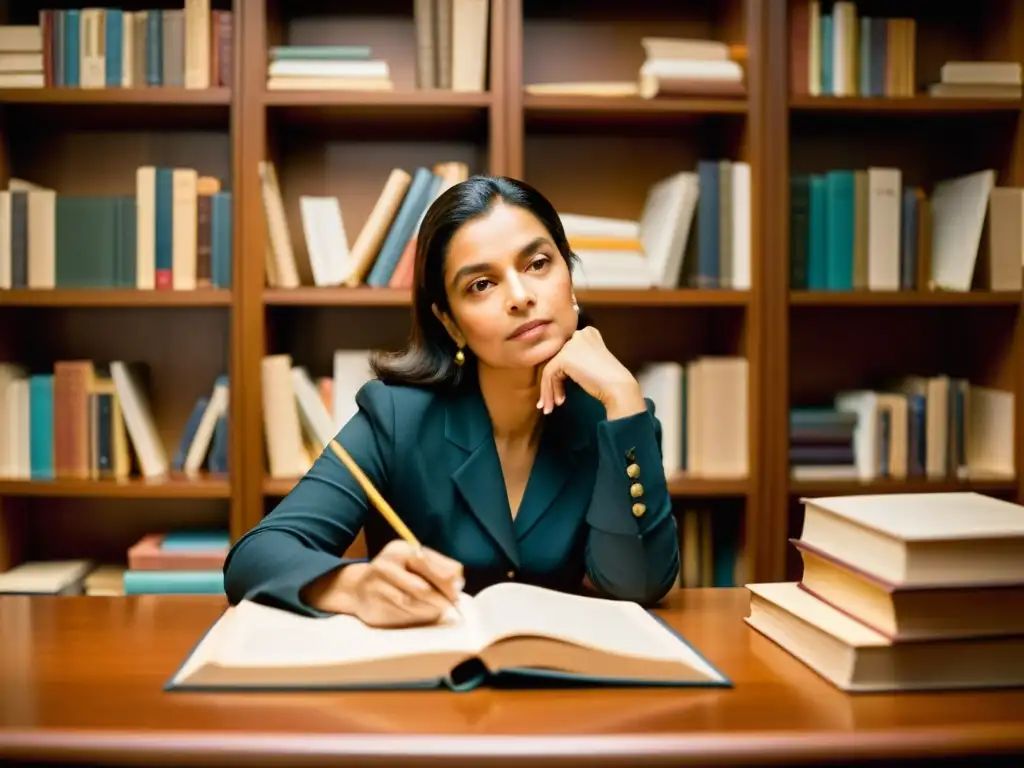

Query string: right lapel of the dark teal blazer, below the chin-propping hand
[514,385,593,539]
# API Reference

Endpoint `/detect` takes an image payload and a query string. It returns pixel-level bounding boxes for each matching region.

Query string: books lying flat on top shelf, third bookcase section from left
[524,37,746,99]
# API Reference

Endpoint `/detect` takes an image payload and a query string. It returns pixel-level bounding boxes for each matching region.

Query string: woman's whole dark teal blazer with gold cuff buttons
[224,380,680,615]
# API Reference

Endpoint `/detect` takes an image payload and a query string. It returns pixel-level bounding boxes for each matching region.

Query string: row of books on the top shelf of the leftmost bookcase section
[0,0,232,89]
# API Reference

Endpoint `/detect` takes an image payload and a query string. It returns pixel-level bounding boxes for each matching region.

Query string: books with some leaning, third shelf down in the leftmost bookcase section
[0,359,229,480]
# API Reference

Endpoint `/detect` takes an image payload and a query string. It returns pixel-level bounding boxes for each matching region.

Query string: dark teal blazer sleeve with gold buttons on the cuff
[586,398,680,603]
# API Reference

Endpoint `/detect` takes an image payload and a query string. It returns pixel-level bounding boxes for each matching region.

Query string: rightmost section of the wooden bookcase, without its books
[759,0,1024,578]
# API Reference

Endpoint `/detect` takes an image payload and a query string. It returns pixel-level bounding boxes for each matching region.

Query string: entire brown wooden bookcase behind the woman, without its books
[0,0,1024,581]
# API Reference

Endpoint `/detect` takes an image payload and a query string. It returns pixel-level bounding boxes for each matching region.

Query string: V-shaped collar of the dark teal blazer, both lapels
[444,382,600,567]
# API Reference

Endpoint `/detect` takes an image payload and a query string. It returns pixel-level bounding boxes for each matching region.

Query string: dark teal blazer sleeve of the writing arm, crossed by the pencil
[224,380,394,615]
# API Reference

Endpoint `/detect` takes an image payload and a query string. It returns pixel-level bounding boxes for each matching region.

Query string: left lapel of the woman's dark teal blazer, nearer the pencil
[444,391,519,568]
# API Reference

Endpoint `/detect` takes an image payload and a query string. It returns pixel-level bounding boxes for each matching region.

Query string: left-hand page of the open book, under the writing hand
[213,599,480,667]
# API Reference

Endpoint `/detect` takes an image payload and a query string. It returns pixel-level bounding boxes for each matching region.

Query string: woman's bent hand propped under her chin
[537,326,647,419]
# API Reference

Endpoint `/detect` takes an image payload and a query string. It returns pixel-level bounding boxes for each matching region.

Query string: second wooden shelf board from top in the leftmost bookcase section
[0,288,231,307]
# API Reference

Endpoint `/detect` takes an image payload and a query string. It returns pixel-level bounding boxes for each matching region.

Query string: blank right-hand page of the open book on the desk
[475,584,720,678]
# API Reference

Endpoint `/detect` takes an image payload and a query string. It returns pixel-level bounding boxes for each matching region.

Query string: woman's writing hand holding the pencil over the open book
[306,539,464,628]
